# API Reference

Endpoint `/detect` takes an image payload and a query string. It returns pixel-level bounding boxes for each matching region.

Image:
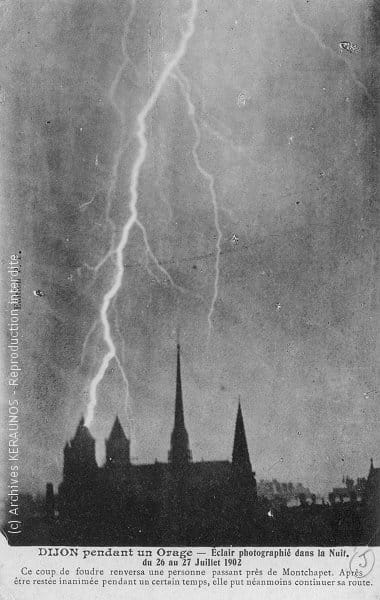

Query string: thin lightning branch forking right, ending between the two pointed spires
[171,68,223,339]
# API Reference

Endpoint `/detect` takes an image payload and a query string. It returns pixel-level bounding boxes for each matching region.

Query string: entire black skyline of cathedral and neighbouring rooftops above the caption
[4,346,380,546]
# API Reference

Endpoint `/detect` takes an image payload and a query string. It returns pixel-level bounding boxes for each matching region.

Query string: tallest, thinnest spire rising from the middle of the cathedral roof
[169,343,191,466]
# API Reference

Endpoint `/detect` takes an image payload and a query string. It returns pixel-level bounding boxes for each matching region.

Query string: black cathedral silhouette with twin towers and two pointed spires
[46,344,270,546]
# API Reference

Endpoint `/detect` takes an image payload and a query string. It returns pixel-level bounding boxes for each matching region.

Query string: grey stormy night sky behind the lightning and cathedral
[0,0,380,494]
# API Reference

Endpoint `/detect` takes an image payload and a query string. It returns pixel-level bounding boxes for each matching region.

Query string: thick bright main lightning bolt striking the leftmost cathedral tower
[86,0,198,426]
